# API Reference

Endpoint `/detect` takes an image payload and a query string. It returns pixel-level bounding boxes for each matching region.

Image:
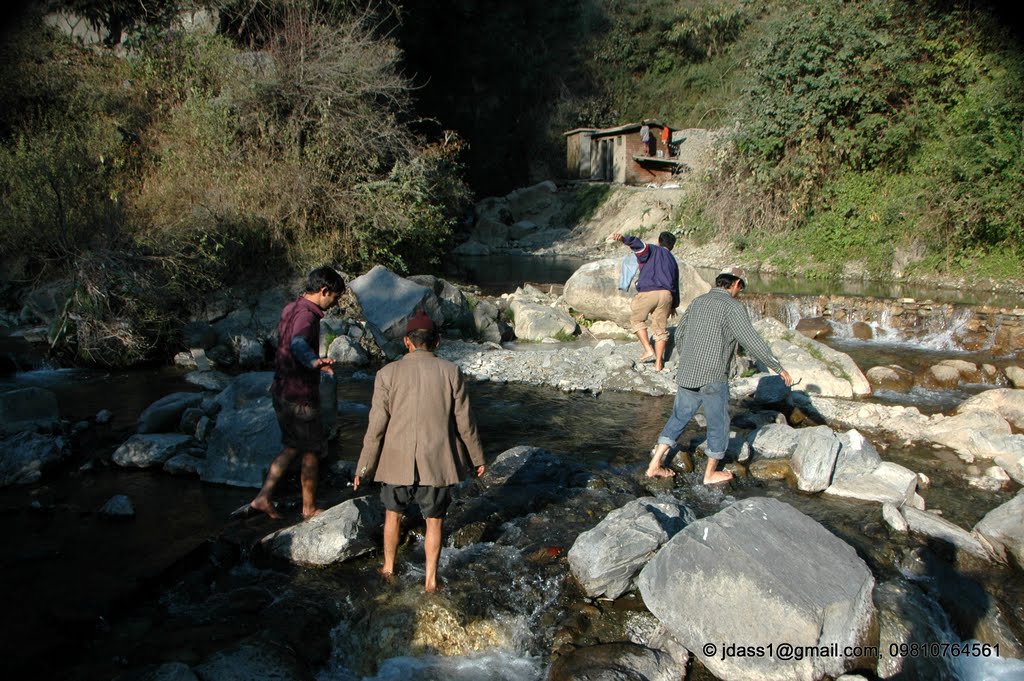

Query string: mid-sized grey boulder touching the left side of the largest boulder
[568,497,695,598]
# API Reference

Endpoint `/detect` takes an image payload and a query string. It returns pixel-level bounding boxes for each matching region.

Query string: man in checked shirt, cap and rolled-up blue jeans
[647,265,793,484]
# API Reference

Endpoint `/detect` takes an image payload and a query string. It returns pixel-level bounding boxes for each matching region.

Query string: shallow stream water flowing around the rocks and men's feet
[0,258,1024,681]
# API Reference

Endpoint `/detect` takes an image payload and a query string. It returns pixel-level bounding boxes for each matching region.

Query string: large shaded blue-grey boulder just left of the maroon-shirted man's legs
[200,396,281,487]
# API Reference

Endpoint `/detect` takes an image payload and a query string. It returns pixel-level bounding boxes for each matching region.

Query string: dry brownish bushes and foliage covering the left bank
[0,0,469,365]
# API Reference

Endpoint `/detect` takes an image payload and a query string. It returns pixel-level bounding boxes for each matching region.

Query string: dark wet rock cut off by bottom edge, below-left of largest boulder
[548,643,686,681]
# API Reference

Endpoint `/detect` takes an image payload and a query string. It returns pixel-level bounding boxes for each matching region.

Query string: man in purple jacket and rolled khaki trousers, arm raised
[611,231,679,372]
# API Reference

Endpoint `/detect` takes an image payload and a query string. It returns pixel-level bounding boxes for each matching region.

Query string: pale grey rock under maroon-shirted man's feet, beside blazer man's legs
[260,495,384,565]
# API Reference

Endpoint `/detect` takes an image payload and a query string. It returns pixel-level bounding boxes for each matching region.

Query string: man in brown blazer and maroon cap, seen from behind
[352,310,484,592]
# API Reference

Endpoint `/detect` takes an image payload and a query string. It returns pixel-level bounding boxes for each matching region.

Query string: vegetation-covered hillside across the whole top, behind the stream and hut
[0,0,1024,365]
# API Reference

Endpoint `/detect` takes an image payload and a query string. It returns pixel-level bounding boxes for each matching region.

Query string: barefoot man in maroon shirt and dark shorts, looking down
[250,267,345,518]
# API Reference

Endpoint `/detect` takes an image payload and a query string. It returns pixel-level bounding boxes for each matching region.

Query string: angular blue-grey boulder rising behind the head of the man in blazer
[348,265,434,340]
